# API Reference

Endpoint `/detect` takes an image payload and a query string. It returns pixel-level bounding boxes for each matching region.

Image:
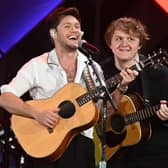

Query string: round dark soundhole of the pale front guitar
[58,100,75,118]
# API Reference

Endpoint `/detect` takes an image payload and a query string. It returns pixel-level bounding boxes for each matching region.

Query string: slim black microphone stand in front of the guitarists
[80,49,117,168]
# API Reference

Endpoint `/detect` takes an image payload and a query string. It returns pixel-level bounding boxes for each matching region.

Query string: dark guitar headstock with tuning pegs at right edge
[141,48,168,68]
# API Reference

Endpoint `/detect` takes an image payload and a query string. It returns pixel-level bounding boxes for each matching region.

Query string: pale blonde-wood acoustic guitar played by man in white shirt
[11,50,167,160]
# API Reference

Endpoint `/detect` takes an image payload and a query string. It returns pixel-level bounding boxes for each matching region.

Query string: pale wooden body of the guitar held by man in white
[11,83,98,160]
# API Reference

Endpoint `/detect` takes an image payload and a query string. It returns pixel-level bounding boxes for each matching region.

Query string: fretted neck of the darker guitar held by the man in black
[124,105,160,125]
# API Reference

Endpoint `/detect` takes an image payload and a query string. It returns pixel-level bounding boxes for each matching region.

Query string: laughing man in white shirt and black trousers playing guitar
[0,8,138,168]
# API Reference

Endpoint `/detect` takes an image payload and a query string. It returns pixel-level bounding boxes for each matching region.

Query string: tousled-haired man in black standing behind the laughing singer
[103,17,168,168]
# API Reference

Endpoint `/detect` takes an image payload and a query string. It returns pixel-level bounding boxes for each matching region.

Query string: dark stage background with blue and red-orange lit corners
[0,0,168,168]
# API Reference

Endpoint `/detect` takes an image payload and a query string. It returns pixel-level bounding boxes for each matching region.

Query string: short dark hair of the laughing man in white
[46,7,81,29]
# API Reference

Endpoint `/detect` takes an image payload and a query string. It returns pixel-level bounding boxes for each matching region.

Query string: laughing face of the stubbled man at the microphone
[55,15,83,49]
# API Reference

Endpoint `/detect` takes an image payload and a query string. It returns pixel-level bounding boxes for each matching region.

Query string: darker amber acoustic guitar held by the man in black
[94,93,167,161]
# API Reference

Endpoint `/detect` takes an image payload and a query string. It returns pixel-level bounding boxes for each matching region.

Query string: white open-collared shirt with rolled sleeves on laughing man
[1,49,103,138]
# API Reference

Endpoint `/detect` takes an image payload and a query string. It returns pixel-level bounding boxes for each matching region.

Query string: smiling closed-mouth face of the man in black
[110,30,141,61]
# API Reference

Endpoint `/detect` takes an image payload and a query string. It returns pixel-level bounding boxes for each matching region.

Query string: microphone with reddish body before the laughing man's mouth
[78,40,99,55]
